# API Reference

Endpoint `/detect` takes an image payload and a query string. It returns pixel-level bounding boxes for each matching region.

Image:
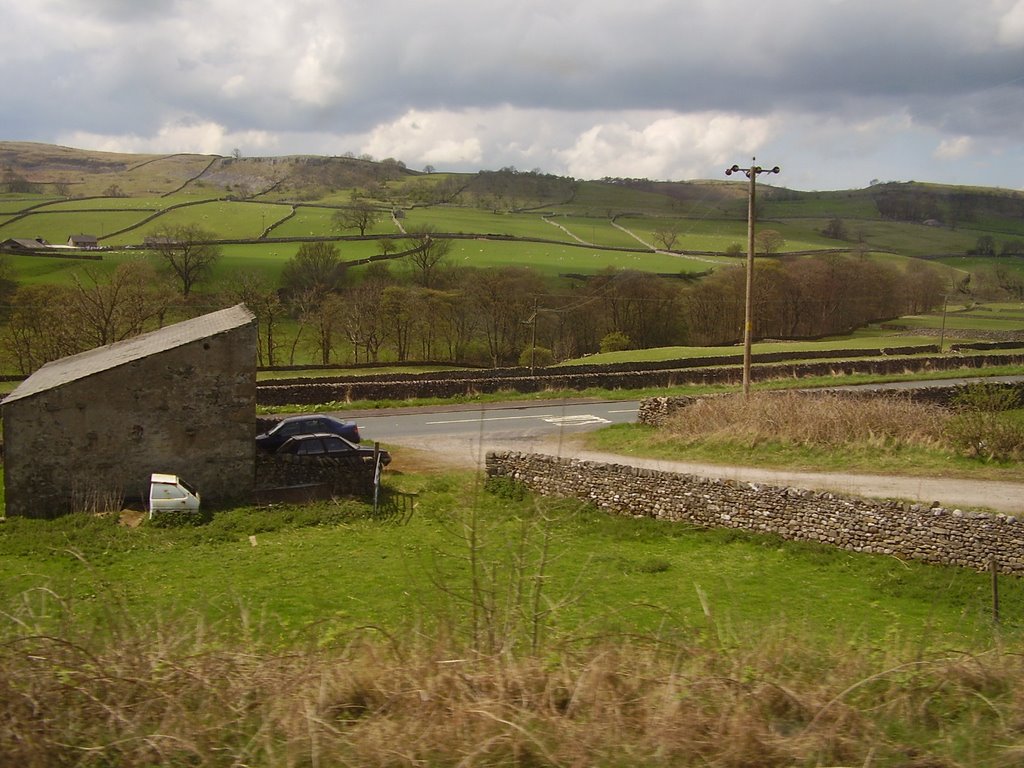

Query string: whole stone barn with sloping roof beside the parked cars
[2,304,256,517]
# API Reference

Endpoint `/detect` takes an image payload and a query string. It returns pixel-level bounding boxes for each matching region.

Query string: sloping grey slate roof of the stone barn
[2,304,255,404]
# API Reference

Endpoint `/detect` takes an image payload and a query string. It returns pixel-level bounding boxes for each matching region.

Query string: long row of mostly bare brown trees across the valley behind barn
[0,227,947,374]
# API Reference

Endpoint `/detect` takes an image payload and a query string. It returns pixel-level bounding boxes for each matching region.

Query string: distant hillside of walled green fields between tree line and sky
[6,141,1024,264]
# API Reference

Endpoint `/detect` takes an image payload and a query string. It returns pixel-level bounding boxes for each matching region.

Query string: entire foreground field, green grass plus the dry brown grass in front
[0,456,1024,768]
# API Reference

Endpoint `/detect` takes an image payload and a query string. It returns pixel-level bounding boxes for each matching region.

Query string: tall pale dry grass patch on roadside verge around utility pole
[665,392,952,447]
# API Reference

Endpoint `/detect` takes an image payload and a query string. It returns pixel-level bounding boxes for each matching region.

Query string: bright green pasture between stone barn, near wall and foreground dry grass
[0,481,1024,648]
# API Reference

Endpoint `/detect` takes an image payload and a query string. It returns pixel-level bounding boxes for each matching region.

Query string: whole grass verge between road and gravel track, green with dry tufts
[581,392,1024,482]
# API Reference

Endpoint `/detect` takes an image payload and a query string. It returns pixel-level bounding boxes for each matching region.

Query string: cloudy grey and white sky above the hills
[0,0,1024,189]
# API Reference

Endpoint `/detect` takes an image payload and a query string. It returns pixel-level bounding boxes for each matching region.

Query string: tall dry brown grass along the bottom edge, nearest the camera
[0,598,1024,768]
